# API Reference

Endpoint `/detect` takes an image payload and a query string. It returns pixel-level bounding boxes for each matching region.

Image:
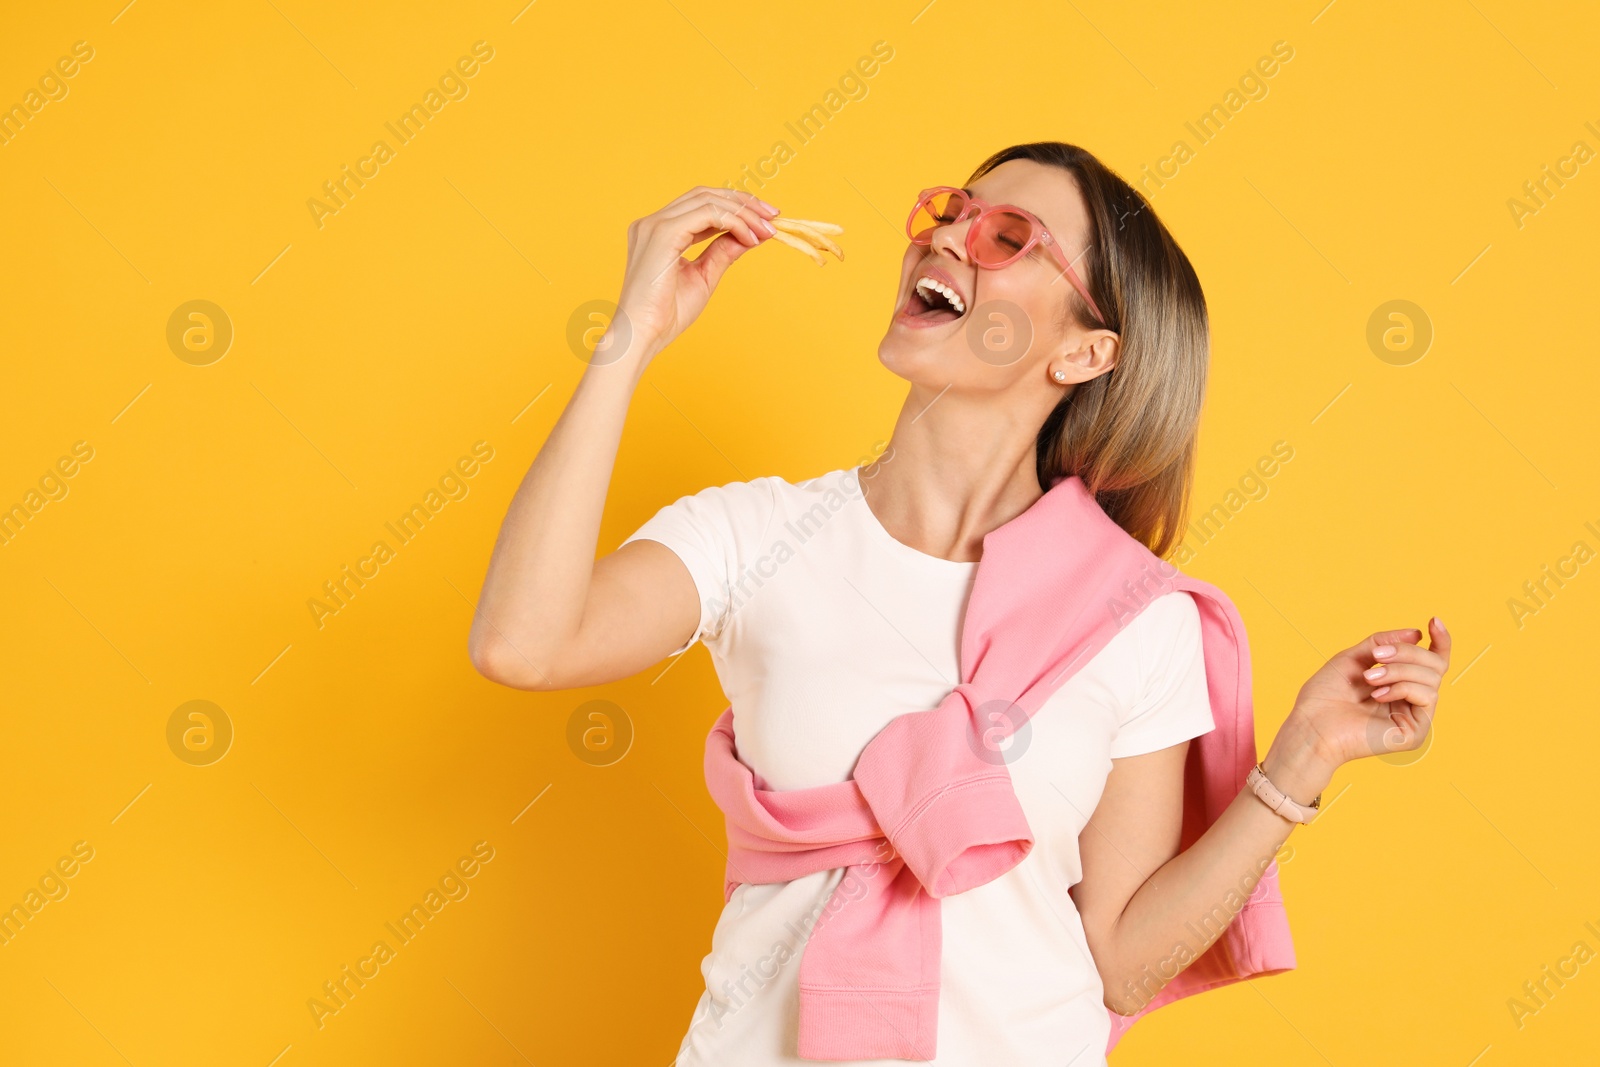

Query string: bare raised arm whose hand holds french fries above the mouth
[467,186,778,689]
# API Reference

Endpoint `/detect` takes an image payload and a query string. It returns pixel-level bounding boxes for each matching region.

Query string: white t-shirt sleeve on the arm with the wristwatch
[1110,590,1216,760]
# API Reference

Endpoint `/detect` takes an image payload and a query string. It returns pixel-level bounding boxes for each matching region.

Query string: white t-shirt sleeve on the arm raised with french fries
[622,478,776,656]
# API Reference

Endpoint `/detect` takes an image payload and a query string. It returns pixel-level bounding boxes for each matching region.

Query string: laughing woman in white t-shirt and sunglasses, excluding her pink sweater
[470,142,1450,1067]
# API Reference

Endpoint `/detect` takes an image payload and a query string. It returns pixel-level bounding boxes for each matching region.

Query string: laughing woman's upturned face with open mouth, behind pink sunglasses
[878,160,1115,392]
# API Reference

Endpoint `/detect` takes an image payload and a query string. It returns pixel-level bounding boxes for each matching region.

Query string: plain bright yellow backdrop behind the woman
[0,0,1600,1067]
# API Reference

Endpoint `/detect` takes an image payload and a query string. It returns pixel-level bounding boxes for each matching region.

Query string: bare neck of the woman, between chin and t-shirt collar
[861,386,1043,561]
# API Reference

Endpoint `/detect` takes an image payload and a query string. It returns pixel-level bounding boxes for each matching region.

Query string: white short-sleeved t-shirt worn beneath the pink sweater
[629,467,1214,1067]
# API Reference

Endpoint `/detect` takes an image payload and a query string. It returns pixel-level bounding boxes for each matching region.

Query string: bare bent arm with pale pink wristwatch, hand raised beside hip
[1072,619,1450,1016]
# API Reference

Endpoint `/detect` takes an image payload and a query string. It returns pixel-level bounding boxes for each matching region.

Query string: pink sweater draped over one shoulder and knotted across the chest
[706,475,1294,1061]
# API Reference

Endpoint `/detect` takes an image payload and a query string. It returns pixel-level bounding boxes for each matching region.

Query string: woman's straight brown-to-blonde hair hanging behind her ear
[966,141,1211,557]
